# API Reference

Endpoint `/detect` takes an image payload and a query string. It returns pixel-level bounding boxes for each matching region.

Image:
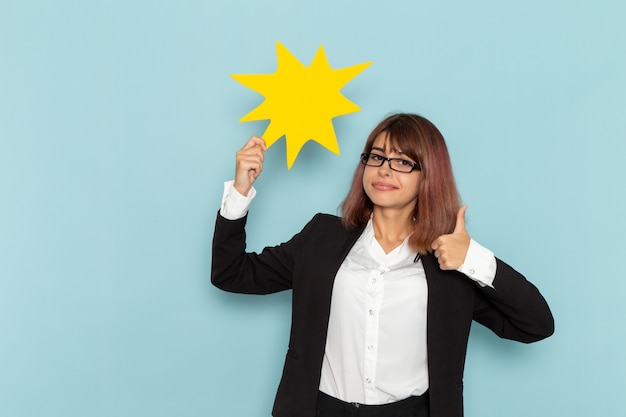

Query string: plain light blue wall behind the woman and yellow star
[0,0,626,417]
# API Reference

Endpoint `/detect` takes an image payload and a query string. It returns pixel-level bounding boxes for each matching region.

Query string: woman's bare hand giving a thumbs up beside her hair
[431,206,471,270]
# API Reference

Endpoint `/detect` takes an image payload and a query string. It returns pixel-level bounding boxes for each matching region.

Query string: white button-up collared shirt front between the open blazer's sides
[320,220,428,404]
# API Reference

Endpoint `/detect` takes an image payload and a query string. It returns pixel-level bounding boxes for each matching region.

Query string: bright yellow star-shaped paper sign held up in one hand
[232,42,371,169]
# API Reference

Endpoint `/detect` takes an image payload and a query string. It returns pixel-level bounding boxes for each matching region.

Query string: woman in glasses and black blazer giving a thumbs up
[211,114,554,417]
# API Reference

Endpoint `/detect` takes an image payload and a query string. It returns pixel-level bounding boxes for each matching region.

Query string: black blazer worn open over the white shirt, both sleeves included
[211,214,554,417]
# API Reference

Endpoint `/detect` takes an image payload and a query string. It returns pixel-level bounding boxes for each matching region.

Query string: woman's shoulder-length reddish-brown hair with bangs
[340,113,461,254]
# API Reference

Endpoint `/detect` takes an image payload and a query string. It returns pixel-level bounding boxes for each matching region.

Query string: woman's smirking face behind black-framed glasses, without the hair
[363,133,422,216]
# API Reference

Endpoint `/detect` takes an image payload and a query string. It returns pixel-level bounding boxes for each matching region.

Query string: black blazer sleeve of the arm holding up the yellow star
[211,213,302,294]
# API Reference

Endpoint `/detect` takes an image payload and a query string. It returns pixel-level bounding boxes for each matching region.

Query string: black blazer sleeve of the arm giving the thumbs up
[474,259,554,343]
